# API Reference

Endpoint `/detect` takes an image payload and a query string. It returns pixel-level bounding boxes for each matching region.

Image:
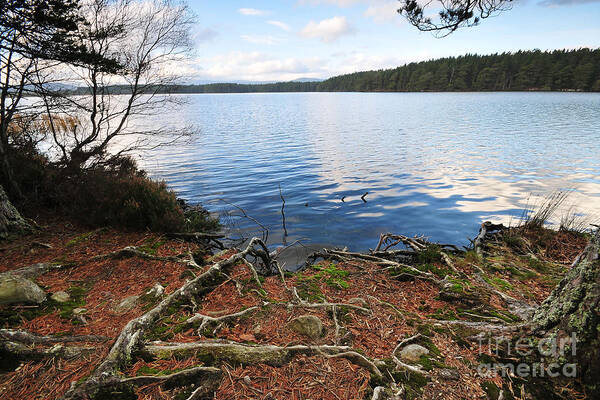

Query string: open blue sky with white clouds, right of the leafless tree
[182,0,600,82]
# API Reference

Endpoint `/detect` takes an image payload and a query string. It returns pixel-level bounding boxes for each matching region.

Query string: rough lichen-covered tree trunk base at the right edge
[533,230,600,398]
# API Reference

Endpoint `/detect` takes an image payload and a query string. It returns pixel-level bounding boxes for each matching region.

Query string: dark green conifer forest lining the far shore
[71,48,600,94]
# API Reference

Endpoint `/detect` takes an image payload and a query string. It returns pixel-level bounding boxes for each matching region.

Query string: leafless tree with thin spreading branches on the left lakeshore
[40,0,193,171]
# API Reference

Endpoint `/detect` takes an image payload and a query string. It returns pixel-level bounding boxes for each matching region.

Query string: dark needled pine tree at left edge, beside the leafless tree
[0,0,91,197]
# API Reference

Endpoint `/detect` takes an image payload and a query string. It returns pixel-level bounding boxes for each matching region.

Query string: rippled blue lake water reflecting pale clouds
[136,93,600,250]
